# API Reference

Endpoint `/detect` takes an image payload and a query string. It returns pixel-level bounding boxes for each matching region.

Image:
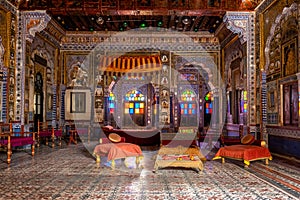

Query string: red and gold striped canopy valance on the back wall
[98,55,162,74]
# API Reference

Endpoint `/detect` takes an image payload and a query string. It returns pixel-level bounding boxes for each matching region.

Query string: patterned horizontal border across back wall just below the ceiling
[61,30,220,51]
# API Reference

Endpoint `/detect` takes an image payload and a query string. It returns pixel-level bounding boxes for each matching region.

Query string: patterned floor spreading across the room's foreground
[0,143,300,200]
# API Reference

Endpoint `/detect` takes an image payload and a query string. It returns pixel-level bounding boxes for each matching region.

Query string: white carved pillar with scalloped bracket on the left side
[15,11,51,125]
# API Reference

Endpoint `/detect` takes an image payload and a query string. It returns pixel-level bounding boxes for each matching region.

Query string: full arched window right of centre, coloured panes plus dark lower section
[180,89,197,126]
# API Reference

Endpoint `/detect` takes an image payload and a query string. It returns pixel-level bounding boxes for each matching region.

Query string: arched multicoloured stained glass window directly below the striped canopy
[124,90,145,115]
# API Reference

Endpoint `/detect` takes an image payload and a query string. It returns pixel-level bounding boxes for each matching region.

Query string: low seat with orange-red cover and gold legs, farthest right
[213,144,272,167]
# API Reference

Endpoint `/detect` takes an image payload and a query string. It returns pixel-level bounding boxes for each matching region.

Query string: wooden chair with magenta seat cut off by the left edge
[0,123,36,164]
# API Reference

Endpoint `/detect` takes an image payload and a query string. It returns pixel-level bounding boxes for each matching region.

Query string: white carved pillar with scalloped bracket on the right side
[224,12,256,133]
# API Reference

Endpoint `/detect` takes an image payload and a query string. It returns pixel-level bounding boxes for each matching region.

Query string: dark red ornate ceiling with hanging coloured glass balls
[10,0,258,33]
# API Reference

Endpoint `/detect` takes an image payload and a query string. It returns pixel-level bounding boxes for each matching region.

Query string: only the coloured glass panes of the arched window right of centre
[180,90,196,115]
